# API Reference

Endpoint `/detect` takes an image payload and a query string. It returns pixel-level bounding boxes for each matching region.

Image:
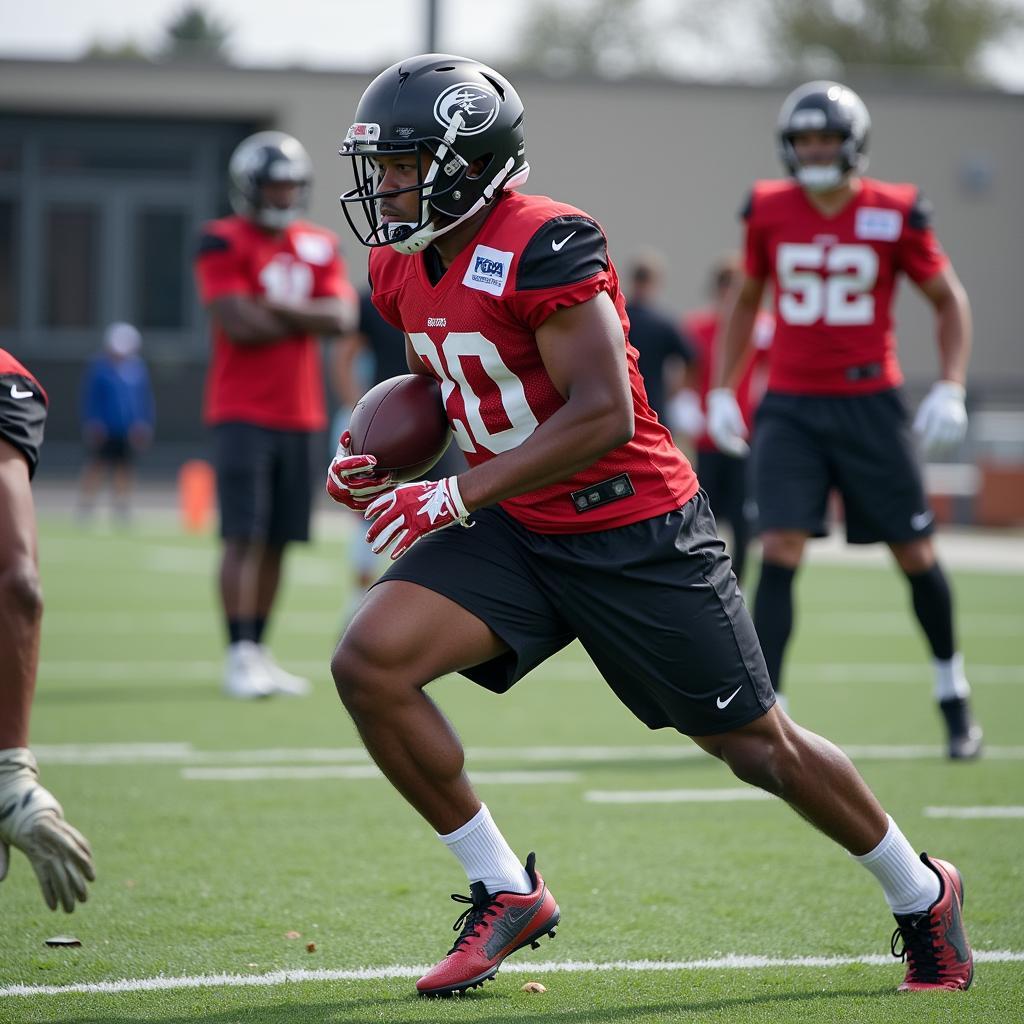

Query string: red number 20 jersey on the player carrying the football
[370,193,697,534]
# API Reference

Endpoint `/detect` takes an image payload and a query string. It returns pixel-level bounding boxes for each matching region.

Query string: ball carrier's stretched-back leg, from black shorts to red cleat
[562,495,970,987]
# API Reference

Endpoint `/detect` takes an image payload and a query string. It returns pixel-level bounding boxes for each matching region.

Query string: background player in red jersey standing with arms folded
[196,131,355,698]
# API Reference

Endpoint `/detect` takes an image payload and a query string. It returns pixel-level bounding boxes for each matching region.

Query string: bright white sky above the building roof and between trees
[0,0,1024,92]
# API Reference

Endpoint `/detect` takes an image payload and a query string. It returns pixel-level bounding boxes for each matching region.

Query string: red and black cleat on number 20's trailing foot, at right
[892,853,974,992]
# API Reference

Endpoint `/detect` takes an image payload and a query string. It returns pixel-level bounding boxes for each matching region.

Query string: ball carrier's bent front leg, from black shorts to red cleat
[331,510,571,994]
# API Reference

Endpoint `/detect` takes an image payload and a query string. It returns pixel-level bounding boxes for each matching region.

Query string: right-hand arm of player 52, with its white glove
[913,264,971,453]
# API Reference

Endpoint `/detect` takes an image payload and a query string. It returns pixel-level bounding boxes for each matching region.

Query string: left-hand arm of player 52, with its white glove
[707,274,765,457]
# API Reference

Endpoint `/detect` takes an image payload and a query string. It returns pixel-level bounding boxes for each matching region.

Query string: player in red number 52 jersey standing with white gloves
[708,82,981,759]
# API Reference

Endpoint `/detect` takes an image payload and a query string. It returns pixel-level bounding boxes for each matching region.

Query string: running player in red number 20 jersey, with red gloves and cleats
[328,54,971,994]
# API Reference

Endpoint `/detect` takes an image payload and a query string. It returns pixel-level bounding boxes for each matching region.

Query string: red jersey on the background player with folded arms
[196,217,355,430]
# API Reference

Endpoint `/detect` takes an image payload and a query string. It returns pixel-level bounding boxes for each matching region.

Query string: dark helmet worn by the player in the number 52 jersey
[778,82,871,191]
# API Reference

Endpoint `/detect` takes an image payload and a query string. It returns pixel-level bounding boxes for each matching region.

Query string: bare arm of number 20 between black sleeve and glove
[459,292,633,510]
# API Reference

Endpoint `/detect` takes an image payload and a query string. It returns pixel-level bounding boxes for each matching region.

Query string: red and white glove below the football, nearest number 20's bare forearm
[364,476,469,561]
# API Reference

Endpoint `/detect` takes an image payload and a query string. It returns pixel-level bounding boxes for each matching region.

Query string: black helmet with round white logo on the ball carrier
[339,53,529,253]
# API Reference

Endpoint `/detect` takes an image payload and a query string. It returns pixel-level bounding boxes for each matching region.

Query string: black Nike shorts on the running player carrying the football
[379,492,775,736]
